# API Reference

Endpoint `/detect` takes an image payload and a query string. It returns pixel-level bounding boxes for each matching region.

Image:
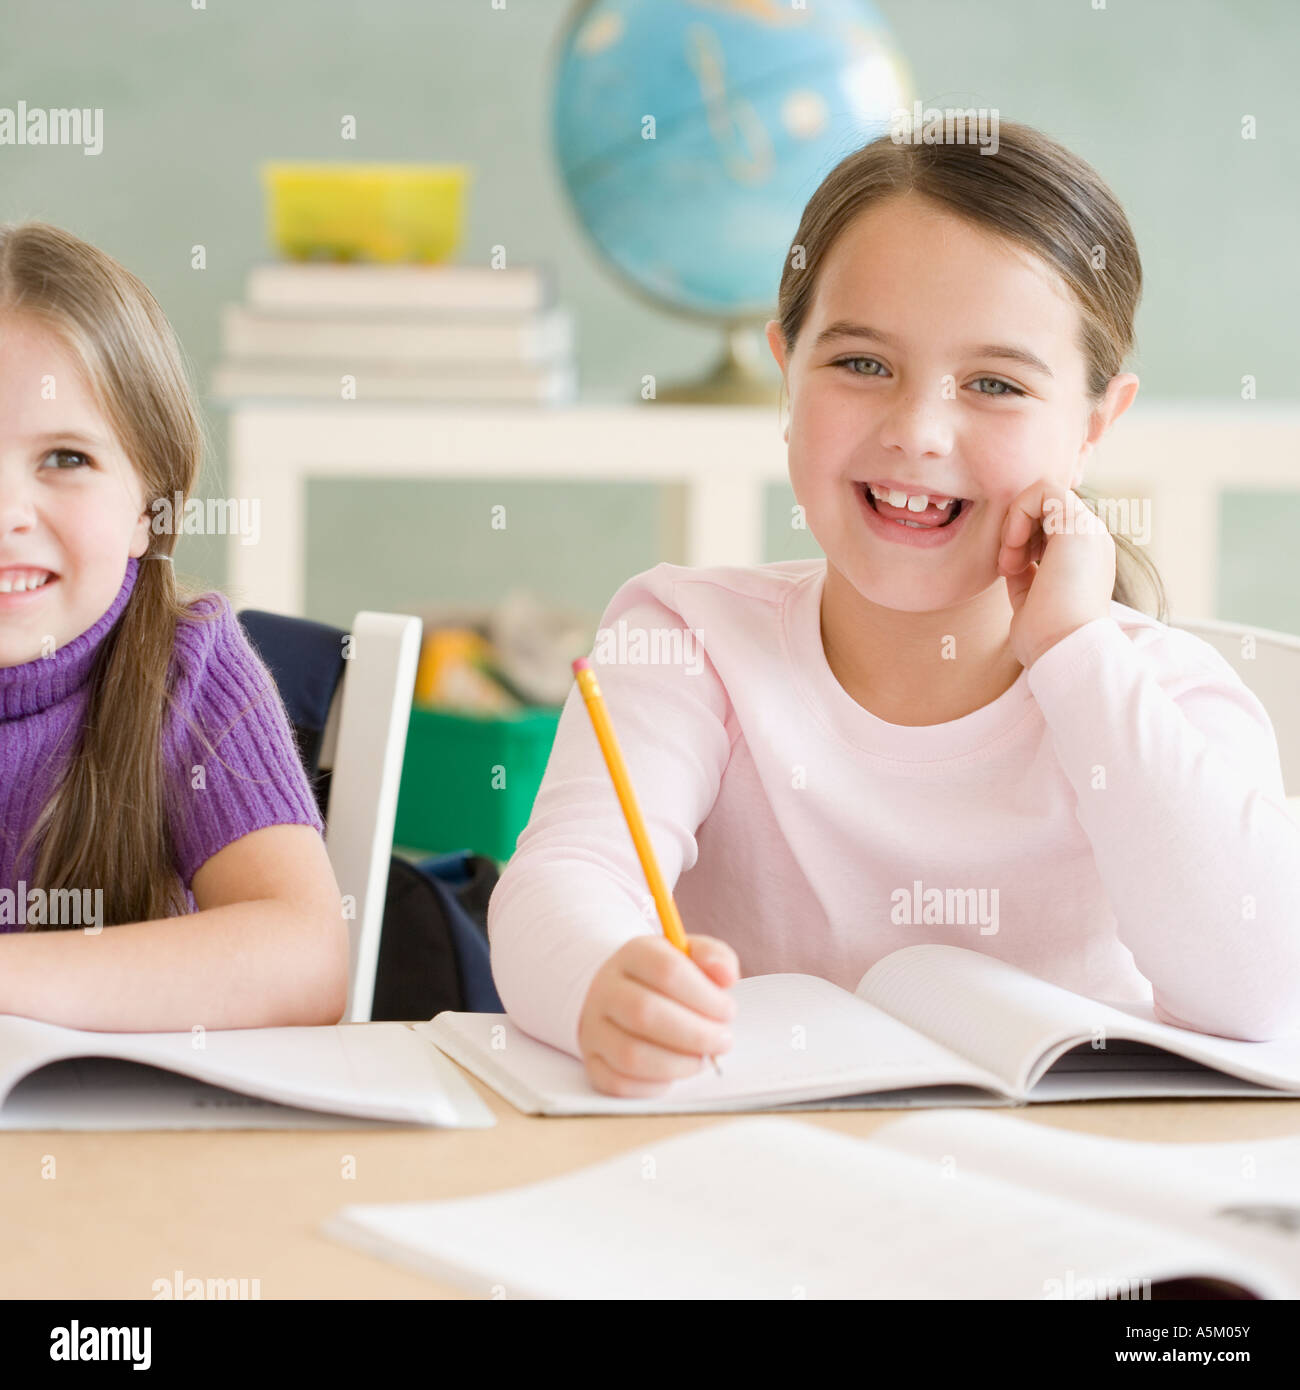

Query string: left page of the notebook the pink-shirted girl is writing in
[417,974,993,1113]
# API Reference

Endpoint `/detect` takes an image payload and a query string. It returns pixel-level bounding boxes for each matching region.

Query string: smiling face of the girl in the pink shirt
[767,193,1137,612]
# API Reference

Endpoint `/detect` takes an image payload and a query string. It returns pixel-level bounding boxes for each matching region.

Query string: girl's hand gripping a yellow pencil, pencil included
[573,657,740,1095]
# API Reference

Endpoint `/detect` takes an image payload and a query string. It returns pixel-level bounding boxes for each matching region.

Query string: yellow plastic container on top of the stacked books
[261,161,470,263]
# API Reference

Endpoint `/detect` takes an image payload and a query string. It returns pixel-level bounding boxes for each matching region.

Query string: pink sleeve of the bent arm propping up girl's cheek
[1029,623,1300,1041]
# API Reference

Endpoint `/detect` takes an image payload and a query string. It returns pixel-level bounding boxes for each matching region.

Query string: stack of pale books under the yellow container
[213,263,577,404]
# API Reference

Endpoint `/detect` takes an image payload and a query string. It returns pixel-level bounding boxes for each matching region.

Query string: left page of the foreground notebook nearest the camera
[315,1118,1251,1300]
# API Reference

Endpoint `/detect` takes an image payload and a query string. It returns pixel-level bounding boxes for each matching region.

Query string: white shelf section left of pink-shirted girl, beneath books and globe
[227,400,787,616]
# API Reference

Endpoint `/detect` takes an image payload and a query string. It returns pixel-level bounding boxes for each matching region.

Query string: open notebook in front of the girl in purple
[0,1013,496,1130]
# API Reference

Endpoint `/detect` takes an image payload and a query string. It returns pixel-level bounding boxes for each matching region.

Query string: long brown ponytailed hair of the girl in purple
[0,221,214,930]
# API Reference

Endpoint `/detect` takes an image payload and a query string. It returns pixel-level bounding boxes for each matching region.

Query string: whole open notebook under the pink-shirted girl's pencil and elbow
[416,945,1300,1115]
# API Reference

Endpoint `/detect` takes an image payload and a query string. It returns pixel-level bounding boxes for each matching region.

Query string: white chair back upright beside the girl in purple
[318,612,423,1023]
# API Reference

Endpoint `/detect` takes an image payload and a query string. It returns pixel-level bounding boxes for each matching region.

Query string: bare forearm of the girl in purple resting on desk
[0,898,348,1033]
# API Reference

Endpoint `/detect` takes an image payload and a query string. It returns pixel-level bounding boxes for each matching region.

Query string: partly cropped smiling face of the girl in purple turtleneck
[0,314,150,667]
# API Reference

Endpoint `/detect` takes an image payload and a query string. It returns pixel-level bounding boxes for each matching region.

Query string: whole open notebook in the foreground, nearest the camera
[324,1111,1300,1300]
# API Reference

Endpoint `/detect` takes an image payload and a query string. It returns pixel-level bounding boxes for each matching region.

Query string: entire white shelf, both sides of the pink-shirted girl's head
[218,400,1300,617]
